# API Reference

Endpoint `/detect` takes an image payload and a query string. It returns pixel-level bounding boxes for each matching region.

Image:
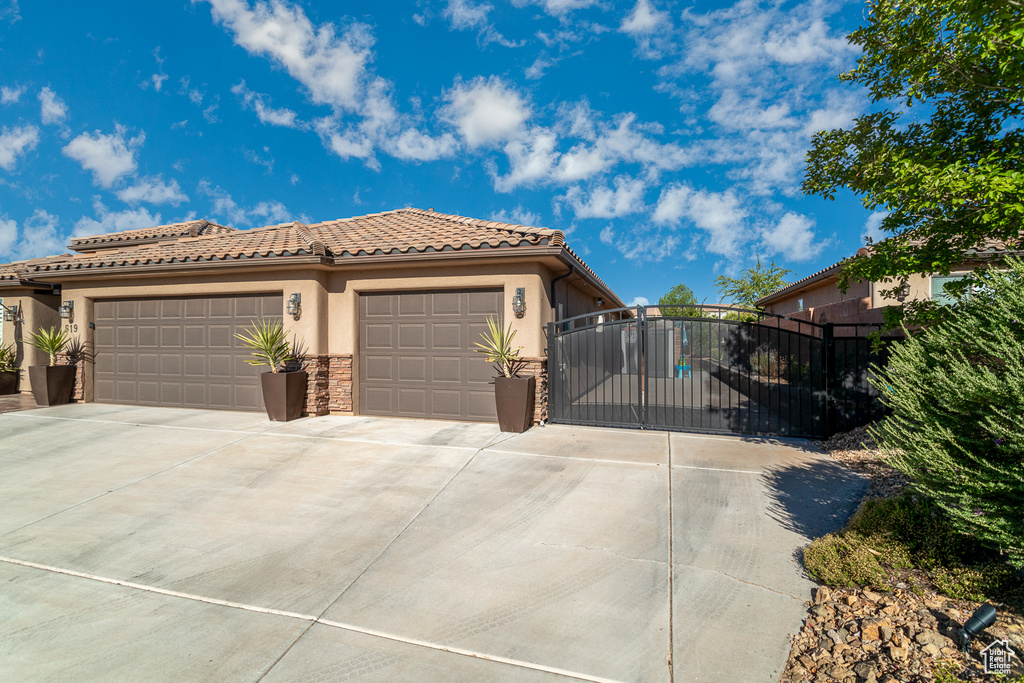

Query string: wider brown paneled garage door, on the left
[94,294,284,411]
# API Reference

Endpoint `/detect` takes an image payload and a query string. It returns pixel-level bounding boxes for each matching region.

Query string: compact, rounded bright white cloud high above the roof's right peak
[443,76,530,147]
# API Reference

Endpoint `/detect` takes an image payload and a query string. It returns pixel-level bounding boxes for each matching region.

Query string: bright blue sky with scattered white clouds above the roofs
[0,0,881,303]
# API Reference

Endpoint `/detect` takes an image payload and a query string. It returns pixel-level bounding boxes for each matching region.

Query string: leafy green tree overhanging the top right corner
[803,0,1024,307]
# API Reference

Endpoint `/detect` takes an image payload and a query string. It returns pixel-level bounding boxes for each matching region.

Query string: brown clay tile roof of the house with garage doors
[0,208,610,291]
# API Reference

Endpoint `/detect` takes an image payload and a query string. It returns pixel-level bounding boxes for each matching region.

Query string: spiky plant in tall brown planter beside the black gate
[475,317,537,433]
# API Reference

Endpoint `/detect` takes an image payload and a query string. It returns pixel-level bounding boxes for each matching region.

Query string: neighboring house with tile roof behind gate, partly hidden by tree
[757,243,1020,324]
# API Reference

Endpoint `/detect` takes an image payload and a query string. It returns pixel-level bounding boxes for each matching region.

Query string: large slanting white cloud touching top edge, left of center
[201,0,373,110]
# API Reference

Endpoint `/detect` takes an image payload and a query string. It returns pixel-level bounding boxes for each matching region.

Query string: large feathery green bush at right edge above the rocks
[870,259,1024,567]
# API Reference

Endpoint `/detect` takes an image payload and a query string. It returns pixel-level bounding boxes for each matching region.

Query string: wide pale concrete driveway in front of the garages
[0,404,865,683]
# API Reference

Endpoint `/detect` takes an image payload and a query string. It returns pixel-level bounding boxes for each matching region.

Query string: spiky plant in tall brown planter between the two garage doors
[234,319,306,422]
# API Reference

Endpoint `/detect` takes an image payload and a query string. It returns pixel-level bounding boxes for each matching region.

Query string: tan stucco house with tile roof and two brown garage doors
[0,208,624,421]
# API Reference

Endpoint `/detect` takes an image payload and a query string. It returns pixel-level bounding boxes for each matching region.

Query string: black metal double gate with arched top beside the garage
[548,306,888,437]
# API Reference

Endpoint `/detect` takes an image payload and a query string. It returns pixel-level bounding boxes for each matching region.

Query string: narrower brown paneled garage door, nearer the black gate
[359,290,502,422]
